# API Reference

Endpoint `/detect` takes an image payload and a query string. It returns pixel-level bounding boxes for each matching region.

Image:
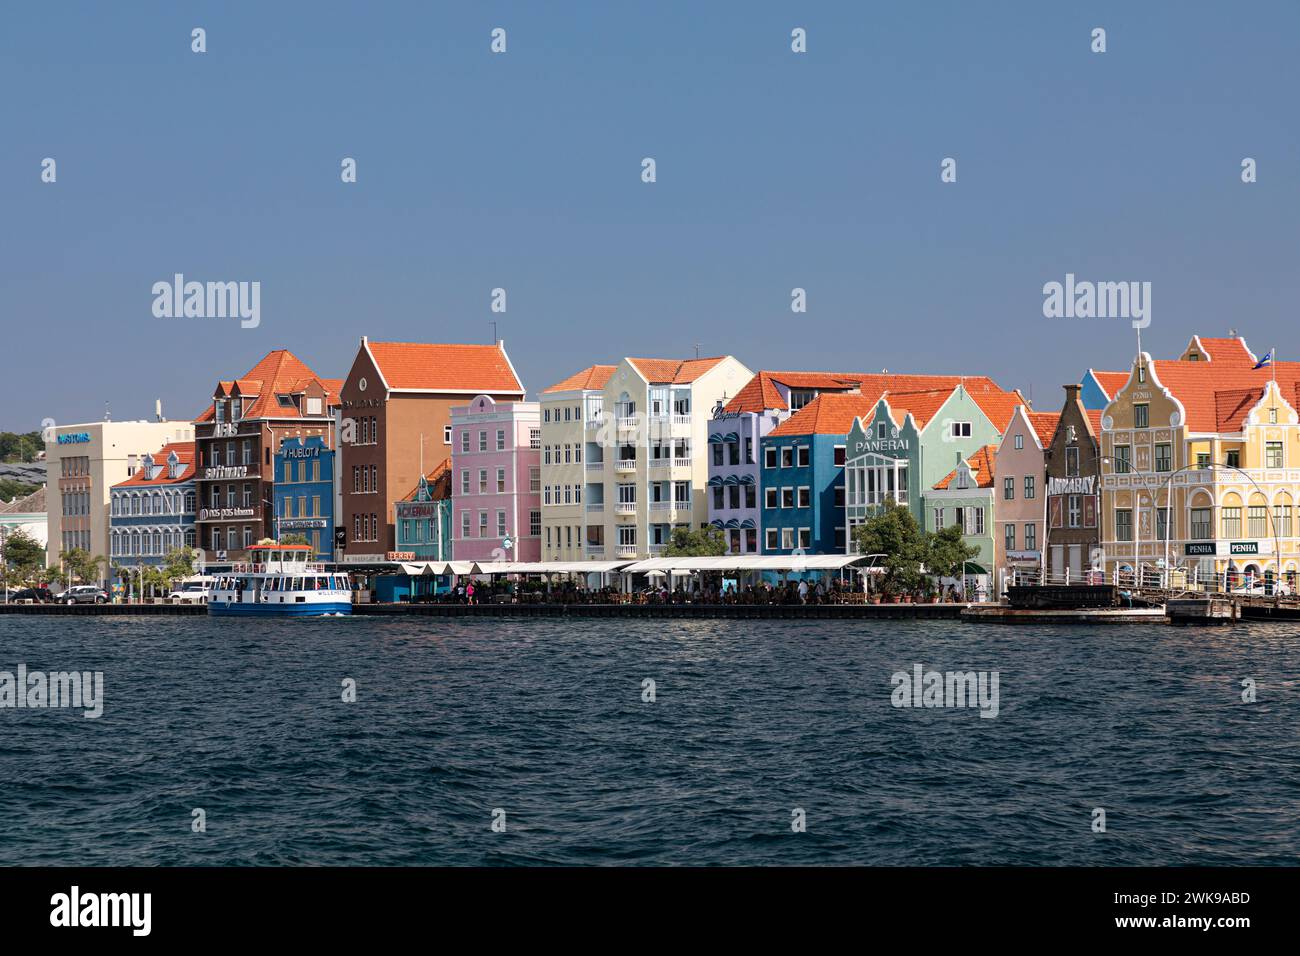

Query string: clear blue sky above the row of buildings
[0,0,1300,431]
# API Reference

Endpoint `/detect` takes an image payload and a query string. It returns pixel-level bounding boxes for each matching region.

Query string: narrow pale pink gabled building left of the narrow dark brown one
[993,405,1061,594]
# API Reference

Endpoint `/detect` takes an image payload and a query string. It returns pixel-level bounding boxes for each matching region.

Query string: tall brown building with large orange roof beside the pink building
[338,336,524,563]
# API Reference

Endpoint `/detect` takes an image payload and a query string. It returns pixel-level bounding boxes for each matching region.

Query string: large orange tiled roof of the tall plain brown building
[367,342,524,394]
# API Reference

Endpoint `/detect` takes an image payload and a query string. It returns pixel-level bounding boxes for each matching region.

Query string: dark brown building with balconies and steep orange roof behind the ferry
[194,349,342,567]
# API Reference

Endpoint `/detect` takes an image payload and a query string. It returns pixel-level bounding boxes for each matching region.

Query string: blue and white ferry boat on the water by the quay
[208,544,352,618]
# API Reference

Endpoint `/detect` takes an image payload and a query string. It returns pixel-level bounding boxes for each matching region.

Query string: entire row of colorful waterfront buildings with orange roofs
[38,337,1300,594]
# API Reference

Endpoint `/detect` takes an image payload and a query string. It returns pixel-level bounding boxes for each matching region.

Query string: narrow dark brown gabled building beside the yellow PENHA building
[1043,385,1101,584]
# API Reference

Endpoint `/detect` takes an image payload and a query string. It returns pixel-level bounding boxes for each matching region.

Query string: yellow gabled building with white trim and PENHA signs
[1101,338,1300,588]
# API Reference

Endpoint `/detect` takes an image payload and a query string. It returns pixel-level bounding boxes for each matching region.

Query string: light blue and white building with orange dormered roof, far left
[108,442,196,567]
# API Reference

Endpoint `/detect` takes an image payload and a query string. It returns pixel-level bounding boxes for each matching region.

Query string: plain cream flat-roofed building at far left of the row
[46,421,195,583]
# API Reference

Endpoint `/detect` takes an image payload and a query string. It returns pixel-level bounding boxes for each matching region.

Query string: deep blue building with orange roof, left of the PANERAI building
[759,393,876,554]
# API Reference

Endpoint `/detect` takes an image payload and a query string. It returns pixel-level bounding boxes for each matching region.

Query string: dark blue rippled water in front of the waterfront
[0,617,1300,865]
